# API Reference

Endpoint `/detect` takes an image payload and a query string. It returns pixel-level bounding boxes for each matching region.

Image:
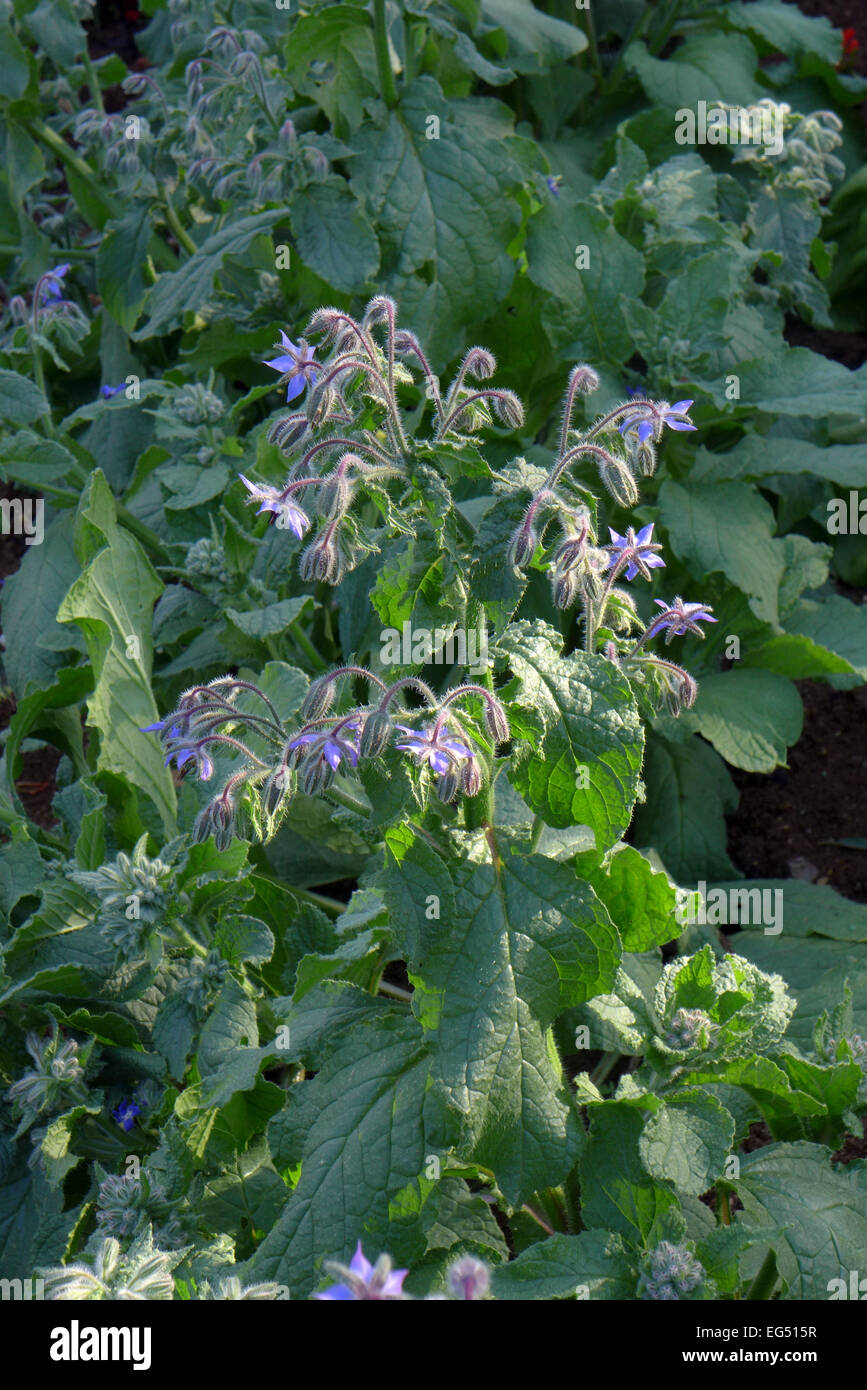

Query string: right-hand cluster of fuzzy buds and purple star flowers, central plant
[507,366,716,716]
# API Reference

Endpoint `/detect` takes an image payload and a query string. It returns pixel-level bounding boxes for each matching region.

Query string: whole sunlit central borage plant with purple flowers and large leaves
[122,297,860,1300]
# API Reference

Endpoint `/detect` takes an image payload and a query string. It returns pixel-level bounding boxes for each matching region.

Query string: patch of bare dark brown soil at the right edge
[728,681,867,902]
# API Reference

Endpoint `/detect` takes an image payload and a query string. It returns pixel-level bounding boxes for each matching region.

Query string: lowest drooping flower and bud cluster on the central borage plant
[141,666,510,850]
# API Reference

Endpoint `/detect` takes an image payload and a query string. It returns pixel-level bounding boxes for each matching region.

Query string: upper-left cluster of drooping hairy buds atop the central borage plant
[242,295,524,585]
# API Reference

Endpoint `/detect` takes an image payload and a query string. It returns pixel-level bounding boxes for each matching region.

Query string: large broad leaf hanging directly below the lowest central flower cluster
[379,830,620,1204]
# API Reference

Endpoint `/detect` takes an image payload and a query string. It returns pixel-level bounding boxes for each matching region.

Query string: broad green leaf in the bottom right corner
[732,1143,867,1301]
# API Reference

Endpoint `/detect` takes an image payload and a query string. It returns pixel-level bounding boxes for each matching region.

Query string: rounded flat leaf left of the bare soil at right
[684,669,803,773]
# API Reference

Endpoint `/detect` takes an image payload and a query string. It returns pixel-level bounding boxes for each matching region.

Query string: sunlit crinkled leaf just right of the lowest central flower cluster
[497,621,643,852]
